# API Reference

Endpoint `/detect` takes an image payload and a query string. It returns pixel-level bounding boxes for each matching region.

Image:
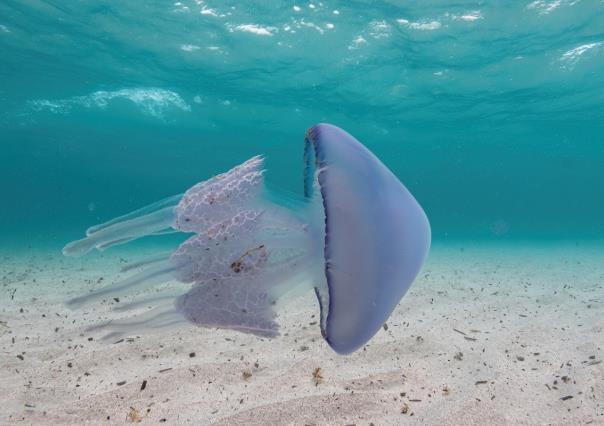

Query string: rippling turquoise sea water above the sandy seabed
[0,0,604,248]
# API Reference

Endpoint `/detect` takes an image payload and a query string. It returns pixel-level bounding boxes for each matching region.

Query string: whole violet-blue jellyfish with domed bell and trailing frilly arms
[63,124,431,354]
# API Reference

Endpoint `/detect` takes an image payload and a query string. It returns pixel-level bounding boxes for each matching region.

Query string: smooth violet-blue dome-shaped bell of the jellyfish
[304,123,431,354]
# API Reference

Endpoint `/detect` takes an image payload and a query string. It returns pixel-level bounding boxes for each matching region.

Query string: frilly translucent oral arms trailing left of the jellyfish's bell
[64,157,323,338]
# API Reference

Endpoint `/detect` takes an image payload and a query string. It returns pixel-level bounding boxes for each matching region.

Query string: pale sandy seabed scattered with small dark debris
[0,243,604,426]
